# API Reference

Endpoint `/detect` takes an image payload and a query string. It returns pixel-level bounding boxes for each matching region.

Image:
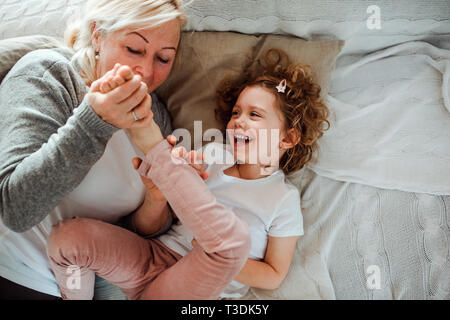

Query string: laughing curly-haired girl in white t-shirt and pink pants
[48,50,328,299]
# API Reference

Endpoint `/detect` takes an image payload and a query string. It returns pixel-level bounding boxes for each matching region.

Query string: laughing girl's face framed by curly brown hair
[227,86,285,165]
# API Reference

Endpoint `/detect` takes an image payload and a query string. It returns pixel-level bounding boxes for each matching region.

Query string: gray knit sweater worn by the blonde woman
[0,49,171,232]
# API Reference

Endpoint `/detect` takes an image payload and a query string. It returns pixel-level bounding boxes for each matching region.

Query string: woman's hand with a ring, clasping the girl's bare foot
[88,64,153,129]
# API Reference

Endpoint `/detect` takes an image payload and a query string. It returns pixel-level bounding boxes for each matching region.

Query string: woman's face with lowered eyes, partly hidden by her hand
[92,19,180,92]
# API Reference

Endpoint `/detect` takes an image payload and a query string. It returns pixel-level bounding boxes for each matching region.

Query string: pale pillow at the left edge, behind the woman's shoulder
[0,35,61,82]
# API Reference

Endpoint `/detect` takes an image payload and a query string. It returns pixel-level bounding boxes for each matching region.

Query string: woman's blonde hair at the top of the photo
[64,0,186,83]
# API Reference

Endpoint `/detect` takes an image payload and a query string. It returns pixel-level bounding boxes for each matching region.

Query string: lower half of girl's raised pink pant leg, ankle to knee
[139,141,248,252]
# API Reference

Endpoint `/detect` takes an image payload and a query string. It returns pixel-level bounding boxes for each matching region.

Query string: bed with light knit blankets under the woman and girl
[0,0,450,300]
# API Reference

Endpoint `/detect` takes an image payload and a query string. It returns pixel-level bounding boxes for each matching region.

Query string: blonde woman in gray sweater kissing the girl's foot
[0,0,185,298]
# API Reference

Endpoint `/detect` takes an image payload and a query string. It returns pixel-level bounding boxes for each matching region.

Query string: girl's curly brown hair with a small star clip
[215,48,330,175]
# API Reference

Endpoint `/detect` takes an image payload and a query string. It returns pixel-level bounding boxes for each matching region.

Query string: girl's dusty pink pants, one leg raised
[47,141,250,299]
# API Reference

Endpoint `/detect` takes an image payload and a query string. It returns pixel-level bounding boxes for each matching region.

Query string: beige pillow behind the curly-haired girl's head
[156,32,344,145]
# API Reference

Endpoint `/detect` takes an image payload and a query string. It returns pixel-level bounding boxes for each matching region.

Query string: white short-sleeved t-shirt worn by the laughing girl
[159,143,303,297]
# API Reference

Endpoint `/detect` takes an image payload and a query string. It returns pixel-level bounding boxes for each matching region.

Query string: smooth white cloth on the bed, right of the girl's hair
[310,41,450,194]
